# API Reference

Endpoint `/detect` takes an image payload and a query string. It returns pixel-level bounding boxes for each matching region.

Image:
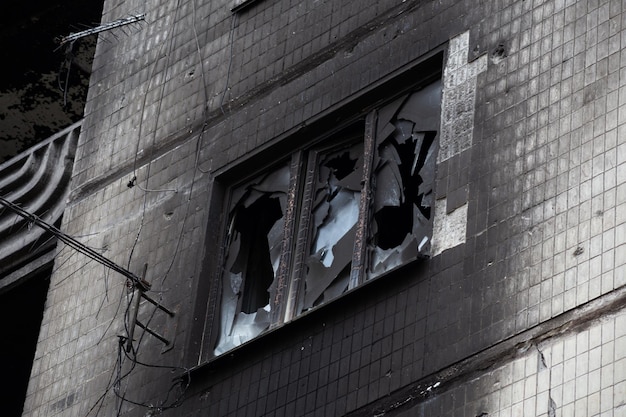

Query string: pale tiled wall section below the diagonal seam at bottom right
[389,310,626,417]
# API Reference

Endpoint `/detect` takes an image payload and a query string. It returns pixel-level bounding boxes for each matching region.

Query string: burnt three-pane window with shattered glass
[213,77,441,355]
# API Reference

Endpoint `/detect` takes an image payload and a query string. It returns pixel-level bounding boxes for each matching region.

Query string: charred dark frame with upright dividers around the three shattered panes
[189,49,444,363]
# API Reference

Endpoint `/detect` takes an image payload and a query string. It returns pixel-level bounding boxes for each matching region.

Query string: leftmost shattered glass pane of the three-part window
[214,165,289,355]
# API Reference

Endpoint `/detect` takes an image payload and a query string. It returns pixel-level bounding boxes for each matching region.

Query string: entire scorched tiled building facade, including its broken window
[19,0,626,417]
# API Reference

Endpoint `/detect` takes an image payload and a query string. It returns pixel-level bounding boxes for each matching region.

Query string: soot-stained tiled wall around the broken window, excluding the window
[25,0,626,416]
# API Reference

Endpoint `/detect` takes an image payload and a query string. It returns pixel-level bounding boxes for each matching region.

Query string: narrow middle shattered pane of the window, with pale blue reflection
[301,143,363,310]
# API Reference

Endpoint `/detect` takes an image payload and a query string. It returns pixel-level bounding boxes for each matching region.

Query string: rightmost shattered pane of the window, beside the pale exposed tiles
[368,82,441,279]
